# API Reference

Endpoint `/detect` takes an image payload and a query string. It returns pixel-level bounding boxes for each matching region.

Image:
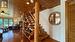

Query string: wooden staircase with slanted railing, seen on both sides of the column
[23,13,58,42]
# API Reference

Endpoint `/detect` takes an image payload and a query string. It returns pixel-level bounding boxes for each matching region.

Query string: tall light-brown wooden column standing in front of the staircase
[34,1,39,42]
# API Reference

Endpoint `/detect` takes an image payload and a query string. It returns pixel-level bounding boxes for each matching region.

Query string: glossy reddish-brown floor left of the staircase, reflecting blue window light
[0,30,28,42]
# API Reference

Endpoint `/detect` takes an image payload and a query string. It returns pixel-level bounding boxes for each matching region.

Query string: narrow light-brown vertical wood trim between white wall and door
[65,1,69,42]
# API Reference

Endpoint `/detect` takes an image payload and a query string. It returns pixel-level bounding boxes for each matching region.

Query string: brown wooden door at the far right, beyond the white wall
[66,1,75,42]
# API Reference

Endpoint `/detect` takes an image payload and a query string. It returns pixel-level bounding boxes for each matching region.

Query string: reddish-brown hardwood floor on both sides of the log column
[0,30,57,42]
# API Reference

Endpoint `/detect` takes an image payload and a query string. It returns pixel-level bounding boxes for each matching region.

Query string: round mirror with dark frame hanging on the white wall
[49,12,61,25]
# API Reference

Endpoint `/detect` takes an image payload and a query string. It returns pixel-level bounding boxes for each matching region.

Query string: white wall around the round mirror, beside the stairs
[40,0,65,42]
